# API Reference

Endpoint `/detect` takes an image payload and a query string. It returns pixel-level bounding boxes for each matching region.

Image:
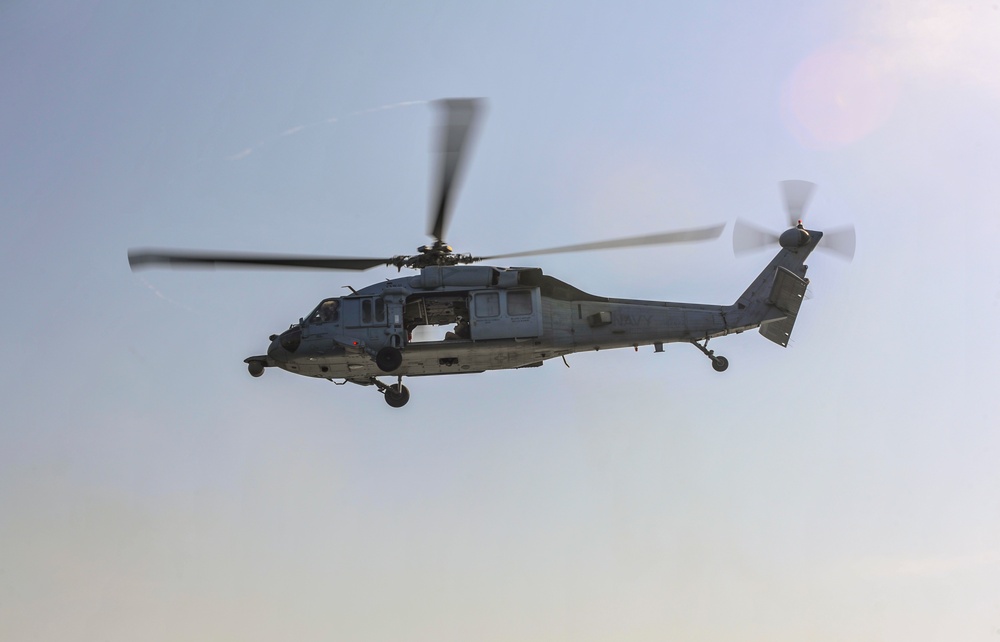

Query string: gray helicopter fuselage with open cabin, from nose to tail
[246,239,818,385]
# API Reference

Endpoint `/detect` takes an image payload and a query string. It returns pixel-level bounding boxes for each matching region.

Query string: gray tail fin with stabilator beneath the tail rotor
[727,230,823,347]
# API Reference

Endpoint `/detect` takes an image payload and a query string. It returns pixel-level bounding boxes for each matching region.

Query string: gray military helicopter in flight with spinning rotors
[128,99,854,408]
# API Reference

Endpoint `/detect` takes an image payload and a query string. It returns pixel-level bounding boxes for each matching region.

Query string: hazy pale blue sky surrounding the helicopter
[0,0,1000,641]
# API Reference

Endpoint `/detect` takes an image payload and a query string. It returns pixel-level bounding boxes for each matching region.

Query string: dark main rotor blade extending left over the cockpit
[128,249,392,270]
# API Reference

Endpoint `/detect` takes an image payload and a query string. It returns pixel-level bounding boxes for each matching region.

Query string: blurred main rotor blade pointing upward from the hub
[427,98,484,241]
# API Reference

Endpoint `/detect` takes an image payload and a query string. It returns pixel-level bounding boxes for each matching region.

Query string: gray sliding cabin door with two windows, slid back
[471,288,542,341]
